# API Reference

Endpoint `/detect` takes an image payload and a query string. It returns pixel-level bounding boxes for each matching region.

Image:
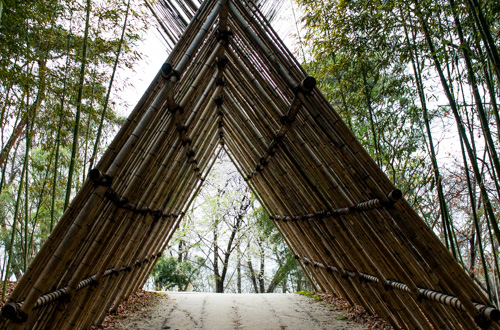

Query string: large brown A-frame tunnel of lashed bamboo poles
[2,0,500,329]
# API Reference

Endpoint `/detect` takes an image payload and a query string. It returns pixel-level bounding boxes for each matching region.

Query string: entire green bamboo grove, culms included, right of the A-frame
[297,0,500,301]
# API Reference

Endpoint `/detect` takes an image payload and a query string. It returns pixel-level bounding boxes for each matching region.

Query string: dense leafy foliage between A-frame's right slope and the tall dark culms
[299,0,430,217]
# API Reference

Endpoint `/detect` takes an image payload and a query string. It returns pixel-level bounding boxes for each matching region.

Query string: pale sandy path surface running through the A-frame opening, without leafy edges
[122,293,365,330]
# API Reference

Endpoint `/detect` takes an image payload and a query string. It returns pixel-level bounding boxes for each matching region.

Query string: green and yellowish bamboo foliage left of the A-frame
[0,0,152,284]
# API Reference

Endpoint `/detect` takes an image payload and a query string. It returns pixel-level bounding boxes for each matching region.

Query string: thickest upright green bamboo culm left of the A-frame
[64,0,91,210]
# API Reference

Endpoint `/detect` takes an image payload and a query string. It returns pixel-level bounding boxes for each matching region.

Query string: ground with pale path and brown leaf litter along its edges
[0,283,392,330]
